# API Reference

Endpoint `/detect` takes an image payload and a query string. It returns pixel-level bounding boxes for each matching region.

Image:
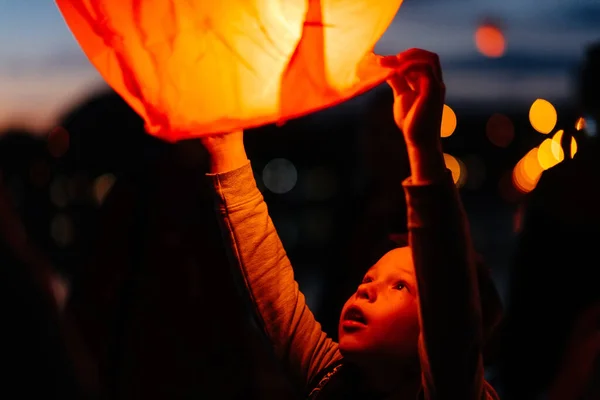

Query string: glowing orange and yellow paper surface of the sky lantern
[56,0,402,141]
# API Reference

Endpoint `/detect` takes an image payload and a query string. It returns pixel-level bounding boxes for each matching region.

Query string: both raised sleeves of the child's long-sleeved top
[208,163,497,400]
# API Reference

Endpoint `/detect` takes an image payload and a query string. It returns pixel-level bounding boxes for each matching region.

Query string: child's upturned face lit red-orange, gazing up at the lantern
[339,247,420,362]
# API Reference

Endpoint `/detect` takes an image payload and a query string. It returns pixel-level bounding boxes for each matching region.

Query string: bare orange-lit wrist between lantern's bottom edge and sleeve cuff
[200,131,248,174]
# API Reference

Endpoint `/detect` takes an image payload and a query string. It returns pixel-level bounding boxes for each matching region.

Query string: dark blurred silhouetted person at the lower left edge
[0,133,85,399]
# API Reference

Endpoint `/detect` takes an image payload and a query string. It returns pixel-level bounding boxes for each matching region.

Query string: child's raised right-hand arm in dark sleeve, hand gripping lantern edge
[383,49,495,400]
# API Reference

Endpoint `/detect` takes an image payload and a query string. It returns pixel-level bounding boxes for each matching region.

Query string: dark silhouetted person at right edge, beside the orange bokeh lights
[500,41,600,400]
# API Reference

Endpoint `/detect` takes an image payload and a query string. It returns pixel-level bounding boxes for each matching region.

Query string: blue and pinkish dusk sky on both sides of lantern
[0,0,600,129]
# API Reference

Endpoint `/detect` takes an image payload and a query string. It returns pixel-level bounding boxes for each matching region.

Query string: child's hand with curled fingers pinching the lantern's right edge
[381,49,446,148]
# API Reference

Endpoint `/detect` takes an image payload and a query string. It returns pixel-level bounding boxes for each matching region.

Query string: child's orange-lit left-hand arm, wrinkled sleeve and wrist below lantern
[203,132,341,387]
